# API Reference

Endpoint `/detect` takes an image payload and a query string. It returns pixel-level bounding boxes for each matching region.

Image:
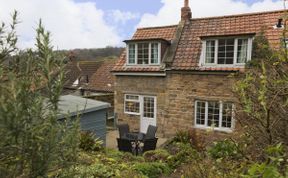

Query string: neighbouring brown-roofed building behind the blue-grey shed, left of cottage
[63,58,116,117]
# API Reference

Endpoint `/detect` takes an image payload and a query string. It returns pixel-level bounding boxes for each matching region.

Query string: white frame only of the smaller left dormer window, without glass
[126,41,161,66]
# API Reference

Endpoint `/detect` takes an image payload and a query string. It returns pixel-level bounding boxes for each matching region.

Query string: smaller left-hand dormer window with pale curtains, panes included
[127,42,161,65]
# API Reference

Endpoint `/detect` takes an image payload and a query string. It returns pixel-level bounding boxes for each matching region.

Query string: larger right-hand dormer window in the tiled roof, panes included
[201,37,252,67]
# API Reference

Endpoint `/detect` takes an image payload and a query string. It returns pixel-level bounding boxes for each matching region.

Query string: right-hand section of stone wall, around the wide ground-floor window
[164,74,240,135]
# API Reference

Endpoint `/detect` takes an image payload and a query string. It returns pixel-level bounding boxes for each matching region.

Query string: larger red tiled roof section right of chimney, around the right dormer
[172,11,284,71]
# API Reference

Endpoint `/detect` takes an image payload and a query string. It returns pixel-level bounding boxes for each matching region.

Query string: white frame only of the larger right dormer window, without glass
[200,36,253,67]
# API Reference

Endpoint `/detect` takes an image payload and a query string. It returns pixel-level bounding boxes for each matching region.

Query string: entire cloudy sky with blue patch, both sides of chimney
[0,0,288,49]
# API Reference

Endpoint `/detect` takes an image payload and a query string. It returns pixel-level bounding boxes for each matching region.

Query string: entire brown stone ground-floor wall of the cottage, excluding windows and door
[115,73,241,136]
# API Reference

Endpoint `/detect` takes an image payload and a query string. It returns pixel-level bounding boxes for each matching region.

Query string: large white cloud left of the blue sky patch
[0,0,121,49]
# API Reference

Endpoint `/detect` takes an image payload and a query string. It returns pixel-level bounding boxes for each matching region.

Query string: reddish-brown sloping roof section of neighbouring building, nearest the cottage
[84,59,116,92]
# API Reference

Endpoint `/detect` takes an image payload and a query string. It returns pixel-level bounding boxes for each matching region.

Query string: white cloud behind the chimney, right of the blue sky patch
[137,0,284,27]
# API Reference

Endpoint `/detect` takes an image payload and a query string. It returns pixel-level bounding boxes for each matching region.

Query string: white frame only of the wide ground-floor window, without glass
[194,100,235,132]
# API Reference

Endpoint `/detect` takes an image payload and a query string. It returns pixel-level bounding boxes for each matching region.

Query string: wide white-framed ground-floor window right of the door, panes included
[195,100,234,131]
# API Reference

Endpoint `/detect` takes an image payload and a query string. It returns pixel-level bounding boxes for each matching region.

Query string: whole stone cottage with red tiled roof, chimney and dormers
[113,0,285,136]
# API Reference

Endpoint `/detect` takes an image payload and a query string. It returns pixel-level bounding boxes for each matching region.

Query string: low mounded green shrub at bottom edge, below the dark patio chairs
[133,162,171,178]
